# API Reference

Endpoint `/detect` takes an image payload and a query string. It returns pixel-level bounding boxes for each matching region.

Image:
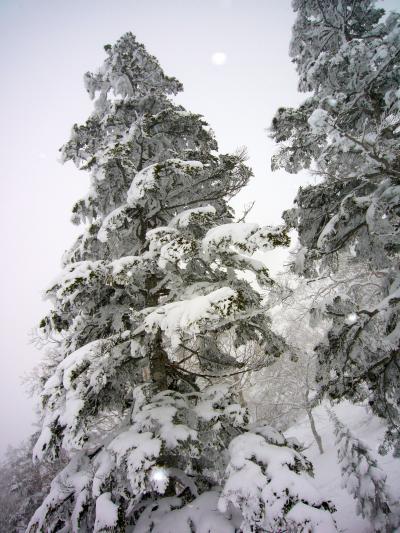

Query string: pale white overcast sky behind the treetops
[0,0,399,454]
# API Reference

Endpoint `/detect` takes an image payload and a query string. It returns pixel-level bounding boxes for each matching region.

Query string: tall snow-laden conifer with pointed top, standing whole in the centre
[30,33,334,533]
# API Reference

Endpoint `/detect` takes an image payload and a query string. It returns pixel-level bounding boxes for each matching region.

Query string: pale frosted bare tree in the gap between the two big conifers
[245,272,335,453]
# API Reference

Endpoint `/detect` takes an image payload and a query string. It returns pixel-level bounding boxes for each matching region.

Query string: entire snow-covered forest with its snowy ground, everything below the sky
[0,0,400,533]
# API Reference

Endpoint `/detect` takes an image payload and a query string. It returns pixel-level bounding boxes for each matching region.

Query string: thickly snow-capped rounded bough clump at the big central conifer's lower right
[218,433,335,533]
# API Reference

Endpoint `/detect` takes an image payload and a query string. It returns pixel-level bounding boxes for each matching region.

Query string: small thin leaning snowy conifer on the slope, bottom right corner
[328,409,400,533]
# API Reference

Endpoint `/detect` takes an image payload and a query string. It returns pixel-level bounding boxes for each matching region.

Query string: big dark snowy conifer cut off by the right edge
[272,0,400,452]
